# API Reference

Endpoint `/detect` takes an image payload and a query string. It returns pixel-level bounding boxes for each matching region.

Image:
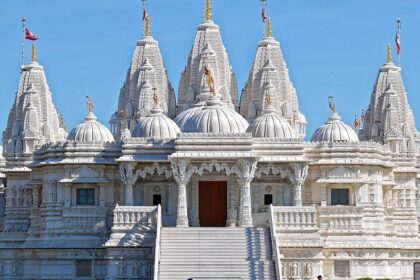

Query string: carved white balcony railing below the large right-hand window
[318,206,363,233]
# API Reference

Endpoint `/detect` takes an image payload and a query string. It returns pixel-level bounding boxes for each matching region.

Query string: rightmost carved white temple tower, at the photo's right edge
[360,45,420,157]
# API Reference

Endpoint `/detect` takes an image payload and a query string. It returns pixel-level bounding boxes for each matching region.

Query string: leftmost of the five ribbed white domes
[67,112,114,144]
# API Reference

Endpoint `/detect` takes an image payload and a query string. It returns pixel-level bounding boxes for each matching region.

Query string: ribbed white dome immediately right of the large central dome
[248,112,295,139]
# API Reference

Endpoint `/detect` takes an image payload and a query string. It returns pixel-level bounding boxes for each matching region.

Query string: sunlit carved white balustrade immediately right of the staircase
[272,206,317,232]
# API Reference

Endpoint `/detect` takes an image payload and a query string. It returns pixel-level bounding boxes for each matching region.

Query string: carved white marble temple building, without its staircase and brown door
[0,1,420,279]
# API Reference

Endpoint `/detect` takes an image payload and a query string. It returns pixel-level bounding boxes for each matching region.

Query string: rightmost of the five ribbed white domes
[311,112,359,143]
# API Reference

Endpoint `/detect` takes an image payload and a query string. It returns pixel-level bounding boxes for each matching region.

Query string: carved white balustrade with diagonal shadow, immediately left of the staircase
[105,205,159,247]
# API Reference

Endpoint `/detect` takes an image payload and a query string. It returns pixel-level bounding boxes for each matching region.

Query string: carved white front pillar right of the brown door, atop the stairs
[238,160,257,227]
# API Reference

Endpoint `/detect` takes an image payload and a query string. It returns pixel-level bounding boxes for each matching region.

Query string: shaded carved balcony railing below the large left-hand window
[63,206,107,231]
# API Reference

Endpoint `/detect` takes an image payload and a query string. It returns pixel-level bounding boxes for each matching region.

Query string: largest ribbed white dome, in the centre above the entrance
[178,97,248,133]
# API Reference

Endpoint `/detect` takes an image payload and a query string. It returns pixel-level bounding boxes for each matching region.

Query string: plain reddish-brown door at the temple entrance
[198,181,227,227]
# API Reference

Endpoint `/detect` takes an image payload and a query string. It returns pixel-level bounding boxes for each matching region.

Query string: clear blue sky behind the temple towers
[0,0,420,139]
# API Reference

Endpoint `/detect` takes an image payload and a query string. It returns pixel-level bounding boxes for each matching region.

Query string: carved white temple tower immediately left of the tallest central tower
[110,11,176,139]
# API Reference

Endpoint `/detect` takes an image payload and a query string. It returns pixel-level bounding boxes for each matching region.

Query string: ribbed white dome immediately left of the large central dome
[133,106,181,139]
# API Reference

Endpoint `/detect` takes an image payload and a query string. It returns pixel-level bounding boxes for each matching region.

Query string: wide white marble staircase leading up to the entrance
[159,228,276,280]
